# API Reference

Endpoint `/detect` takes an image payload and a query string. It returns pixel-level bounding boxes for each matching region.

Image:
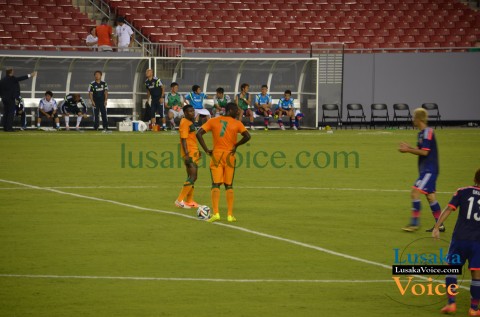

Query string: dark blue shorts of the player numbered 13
[447,240,480,270]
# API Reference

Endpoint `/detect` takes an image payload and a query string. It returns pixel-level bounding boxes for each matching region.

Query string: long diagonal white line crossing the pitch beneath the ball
[0,179,465,288]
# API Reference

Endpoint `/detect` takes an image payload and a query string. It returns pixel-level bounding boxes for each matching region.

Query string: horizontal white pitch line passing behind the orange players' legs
[0,186,455,195]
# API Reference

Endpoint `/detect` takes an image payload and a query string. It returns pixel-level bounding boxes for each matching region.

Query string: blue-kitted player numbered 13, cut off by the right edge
[432,169,480,316]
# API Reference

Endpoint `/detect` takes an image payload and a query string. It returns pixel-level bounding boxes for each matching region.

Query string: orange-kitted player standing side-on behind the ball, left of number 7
[175,105,201,209]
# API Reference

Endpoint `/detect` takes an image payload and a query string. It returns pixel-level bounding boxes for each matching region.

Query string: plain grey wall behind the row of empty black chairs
[343,53,480,121]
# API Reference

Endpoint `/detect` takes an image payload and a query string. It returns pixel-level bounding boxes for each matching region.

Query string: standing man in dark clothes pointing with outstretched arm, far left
[0,68,37,132]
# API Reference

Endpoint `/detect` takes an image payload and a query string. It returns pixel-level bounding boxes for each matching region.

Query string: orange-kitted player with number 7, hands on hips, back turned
[197,102,250,222]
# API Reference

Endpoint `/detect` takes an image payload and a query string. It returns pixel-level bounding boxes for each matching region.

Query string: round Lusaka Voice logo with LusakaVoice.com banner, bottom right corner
[386,237,463,306]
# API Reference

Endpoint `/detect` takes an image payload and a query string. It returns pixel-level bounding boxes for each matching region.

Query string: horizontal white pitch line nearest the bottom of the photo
[0,274,394,283]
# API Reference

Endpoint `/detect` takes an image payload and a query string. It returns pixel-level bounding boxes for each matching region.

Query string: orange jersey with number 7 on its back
[202,116,247,151]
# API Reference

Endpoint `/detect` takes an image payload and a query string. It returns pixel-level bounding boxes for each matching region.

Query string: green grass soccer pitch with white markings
[0,129,480,316]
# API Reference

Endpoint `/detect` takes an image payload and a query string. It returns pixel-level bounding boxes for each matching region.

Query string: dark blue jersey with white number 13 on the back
[448,186,480,241]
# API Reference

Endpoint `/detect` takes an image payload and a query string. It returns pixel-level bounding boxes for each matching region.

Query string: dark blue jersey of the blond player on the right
[417,128,440,174]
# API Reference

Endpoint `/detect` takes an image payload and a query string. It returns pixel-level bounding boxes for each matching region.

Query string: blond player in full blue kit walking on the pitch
[398,108,445,232]
